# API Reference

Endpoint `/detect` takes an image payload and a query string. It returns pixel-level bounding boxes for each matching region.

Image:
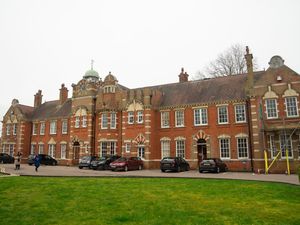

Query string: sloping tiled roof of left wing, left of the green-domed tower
[31,99,72,120]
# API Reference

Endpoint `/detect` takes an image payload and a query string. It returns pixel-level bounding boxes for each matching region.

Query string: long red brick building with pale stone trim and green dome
[1,49,300,172]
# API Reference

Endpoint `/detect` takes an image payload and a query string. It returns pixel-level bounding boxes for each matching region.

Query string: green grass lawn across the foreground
[0,177,300,225]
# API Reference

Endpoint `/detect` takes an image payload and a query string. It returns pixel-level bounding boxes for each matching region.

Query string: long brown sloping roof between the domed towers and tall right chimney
[145,71,264,107]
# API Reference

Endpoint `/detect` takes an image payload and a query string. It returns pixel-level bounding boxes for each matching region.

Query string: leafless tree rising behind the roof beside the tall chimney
[195,44,257,79]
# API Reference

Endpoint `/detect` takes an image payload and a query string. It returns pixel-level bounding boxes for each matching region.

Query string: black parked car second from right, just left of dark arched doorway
[160,157,190,172]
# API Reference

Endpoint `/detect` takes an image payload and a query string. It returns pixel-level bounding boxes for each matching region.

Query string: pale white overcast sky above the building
[0,0,300,133]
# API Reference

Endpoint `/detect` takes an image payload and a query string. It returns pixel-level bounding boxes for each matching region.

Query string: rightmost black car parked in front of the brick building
[199,158,228,173]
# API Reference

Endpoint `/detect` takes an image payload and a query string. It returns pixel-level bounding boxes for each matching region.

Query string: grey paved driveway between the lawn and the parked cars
[0,164,300,185]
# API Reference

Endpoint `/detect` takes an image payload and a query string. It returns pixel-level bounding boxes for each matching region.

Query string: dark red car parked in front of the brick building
[109,157,144,172]
